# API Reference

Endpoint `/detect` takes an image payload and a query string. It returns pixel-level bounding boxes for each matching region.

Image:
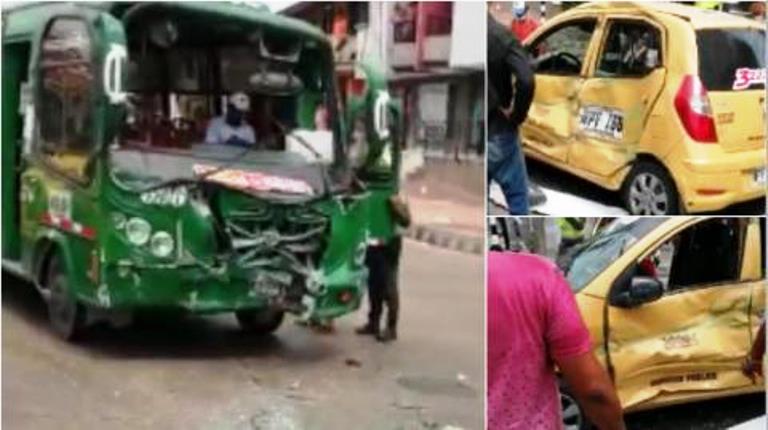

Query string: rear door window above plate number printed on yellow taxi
[595,21,661,77]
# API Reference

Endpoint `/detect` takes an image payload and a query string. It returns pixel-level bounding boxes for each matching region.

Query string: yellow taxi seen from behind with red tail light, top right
[521,2,766,215]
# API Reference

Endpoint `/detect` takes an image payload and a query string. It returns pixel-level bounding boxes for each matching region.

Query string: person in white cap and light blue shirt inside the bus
[205,92,256,146]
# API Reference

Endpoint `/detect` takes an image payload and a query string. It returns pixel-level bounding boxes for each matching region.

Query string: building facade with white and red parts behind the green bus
[282,2,485,159]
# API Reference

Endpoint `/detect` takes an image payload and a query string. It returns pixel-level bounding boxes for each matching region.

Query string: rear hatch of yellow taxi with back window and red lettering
[696,27,765,152]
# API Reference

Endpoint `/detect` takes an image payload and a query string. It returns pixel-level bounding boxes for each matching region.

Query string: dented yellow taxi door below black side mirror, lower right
[605,219,765,410]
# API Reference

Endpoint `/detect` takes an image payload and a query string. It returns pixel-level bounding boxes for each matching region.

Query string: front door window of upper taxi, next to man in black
[528,19,597,76]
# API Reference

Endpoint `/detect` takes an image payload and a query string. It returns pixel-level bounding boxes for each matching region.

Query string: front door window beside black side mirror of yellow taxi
[637,218,745,292]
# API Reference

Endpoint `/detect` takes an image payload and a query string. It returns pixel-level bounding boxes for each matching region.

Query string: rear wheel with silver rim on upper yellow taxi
[621,161,679,215]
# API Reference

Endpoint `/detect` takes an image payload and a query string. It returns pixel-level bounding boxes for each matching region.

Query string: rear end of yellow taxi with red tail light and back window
[651,4,766,212]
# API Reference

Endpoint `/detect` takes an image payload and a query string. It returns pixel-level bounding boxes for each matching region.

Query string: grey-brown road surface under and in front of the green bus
[2,242,484,430]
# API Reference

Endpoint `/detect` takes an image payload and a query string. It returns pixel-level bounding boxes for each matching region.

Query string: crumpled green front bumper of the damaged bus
[88,261,367,318]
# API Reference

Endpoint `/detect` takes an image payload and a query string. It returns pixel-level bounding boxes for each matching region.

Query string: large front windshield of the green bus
[109,19,344,194]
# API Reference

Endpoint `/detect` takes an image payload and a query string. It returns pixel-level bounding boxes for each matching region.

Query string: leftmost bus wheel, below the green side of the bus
[45,253,86,341]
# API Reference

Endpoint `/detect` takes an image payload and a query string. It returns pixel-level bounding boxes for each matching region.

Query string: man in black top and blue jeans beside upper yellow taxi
[487,15,535,215]
